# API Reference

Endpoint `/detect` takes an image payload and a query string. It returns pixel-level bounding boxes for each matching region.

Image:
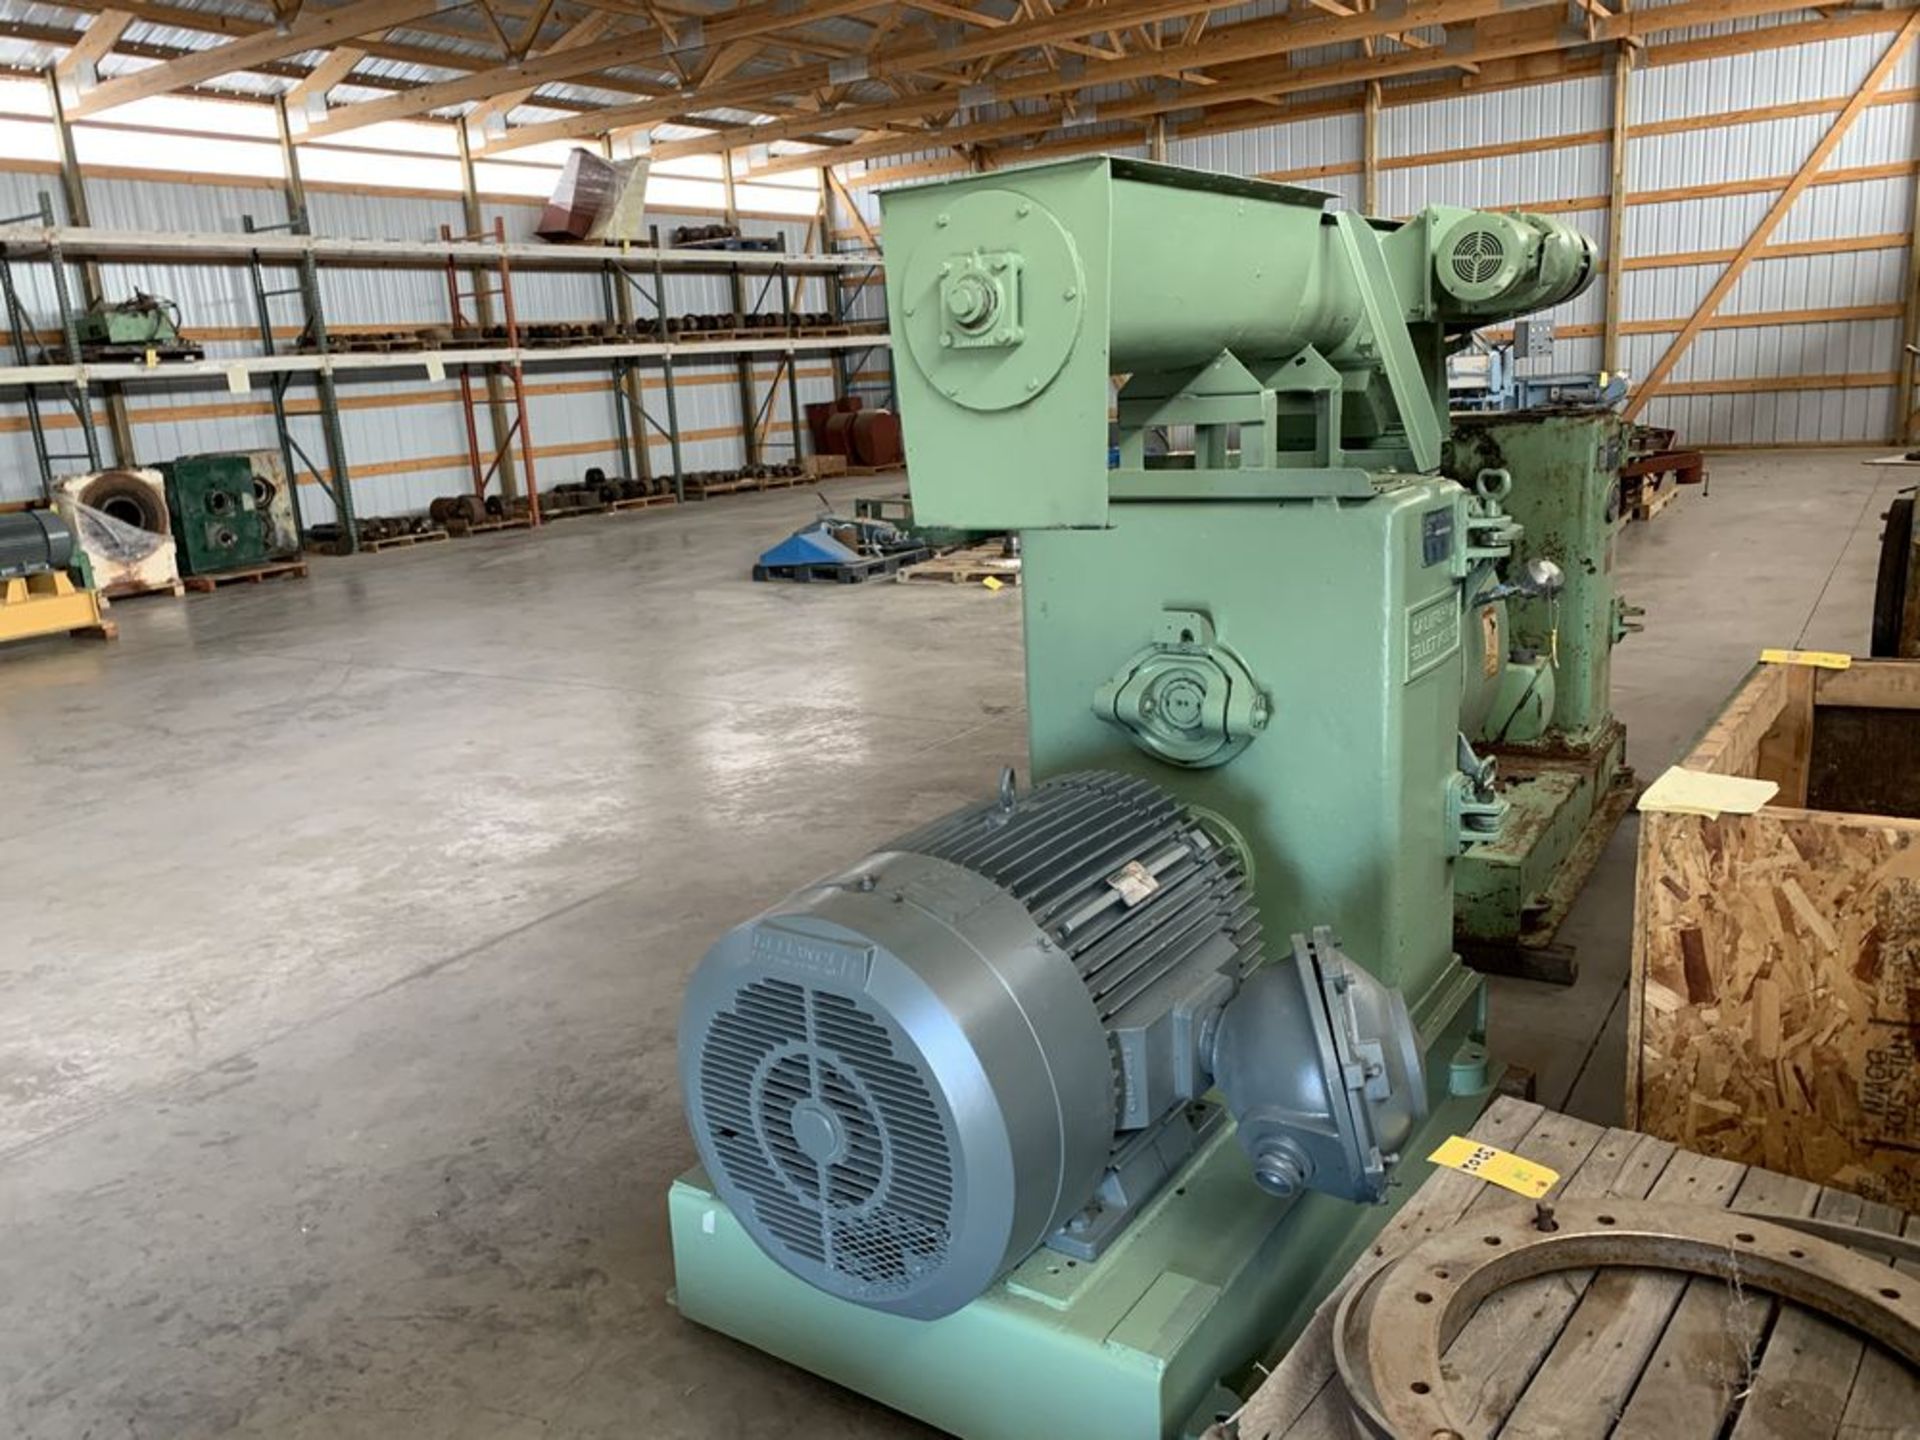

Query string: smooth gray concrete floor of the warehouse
[0,451,1908,1440]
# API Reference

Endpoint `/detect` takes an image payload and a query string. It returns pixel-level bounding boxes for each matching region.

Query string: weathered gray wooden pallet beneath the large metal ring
[1208,1098,1920,1440]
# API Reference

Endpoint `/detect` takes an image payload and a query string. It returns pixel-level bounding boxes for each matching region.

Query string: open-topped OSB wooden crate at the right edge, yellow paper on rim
[1626,660,1920,1210]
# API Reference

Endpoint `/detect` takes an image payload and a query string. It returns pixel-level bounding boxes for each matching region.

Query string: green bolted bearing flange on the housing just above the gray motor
[1092,607,1271,770]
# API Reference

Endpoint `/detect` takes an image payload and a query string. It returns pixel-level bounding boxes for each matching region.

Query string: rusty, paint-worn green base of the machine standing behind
[1453,722,1634,985]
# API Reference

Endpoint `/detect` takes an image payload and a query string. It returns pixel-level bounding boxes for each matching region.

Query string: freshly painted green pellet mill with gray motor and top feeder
[670,157,1594,1440]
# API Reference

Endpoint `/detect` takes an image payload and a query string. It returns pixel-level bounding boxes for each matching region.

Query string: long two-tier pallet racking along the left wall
[0,202,889,545]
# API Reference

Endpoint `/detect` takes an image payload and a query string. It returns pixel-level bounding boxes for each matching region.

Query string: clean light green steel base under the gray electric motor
[668,983,1492,1440]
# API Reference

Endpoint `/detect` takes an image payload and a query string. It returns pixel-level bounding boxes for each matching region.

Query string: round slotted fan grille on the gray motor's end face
[699,979,954,1300]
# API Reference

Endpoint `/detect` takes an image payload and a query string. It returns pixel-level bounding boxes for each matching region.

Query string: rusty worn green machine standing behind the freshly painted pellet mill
[1446,416,1640,983]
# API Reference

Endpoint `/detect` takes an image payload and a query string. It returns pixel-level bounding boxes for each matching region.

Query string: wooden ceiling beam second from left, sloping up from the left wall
[303,0,879,140]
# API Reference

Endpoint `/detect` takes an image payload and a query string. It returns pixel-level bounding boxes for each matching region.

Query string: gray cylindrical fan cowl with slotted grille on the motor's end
[680,852,1114,1319]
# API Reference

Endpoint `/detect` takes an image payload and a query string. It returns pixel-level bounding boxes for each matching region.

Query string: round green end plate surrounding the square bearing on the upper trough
[900,190,1087,411]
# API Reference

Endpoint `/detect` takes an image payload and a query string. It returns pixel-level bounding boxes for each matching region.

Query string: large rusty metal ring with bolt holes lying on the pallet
[1334,1200,1920,1440]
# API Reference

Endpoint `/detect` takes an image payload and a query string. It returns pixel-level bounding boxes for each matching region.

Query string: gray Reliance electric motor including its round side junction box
[680,772,1427,1319]
